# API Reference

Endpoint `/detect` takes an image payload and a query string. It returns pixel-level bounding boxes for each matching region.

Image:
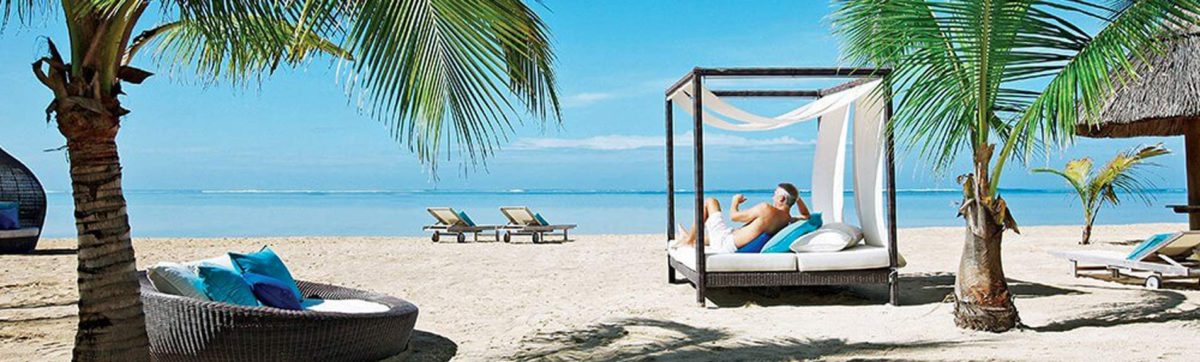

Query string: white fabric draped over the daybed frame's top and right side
[667,79,888,246]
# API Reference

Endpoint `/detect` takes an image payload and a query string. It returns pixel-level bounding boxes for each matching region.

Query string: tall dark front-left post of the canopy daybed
[691,67,708,307]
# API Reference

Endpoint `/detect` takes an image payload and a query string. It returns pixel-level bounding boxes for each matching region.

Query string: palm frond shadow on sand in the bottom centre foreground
[511,318,956,361]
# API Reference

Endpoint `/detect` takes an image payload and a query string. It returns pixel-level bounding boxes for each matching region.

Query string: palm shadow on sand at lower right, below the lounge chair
[1027,290,1200,332]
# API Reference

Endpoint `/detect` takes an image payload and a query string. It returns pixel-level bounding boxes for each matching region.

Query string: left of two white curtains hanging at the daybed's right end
[811,107,850,223]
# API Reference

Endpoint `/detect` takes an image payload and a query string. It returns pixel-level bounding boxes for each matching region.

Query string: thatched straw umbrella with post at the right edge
[1075,30,1200,230]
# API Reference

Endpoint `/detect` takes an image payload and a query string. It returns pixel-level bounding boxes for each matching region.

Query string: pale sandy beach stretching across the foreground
[0,224,1200,361]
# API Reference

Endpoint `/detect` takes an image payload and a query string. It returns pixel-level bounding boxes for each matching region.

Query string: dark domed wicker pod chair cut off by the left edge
[0,149,46,254]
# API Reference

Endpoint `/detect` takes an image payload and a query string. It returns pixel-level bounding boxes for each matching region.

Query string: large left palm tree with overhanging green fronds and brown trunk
[0,0,559,361]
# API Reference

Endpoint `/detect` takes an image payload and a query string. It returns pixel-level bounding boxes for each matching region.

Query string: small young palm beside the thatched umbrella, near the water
[1033,144,1171,245]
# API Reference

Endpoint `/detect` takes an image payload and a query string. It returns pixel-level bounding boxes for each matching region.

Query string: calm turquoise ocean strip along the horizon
[44,189,1187,237]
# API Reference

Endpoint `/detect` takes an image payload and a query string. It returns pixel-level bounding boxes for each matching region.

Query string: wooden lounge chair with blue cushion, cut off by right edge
[1050,231,1200,289]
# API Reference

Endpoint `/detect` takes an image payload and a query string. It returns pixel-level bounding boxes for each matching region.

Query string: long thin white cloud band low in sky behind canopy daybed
[509,132,815,151]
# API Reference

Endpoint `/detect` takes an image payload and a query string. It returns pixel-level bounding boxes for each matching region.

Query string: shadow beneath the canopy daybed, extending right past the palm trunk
[708,273,1082,308]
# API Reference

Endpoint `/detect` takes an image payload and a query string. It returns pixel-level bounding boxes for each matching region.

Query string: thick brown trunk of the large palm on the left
[56,106,150,361]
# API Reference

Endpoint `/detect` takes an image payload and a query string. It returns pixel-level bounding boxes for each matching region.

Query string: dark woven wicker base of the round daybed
[138,272,418,361]
